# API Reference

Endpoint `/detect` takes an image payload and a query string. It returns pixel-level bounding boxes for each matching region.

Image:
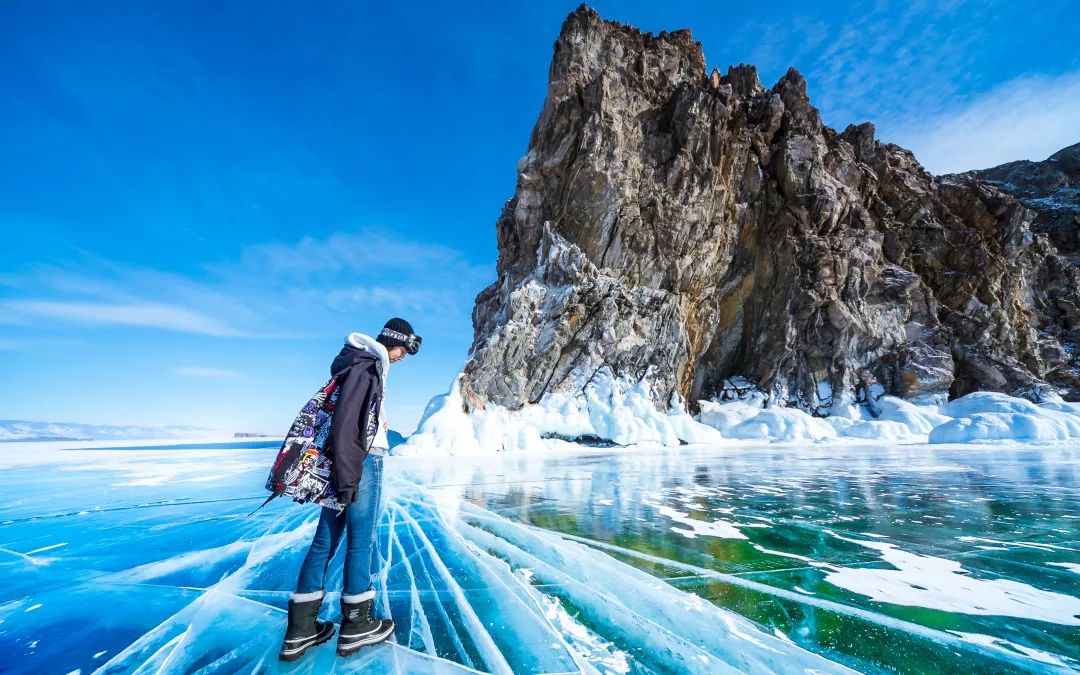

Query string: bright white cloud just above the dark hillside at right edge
[878,72,1080,174]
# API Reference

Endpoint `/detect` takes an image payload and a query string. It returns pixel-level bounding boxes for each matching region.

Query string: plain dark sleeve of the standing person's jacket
[326,366,378,503]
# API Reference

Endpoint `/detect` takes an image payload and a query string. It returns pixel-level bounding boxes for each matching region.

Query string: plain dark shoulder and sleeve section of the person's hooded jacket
[326,345,382,503]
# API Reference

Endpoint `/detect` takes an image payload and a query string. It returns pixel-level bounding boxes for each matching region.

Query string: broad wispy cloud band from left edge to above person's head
[0,228,495,338]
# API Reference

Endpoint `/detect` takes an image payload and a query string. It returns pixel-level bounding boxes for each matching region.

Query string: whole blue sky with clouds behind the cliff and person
[0,0,1080,433]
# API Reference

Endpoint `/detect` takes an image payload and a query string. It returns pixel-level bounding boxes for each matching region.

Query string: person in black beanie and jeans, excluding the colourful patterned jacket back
[279,318,420,661]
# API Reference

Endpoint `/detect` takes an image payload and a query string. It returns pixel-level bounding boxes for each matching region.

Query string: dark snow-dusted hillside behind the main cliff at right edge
[949,143,1080,264]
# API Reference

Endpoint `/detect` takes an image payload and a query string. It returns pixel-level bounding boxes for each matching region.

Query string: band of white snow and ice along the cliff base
[393,368,1080,455]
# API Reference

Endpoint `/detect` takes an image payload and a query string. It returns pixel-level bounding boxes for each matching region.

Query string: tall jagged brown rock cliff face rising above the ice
[462,6,1080,413]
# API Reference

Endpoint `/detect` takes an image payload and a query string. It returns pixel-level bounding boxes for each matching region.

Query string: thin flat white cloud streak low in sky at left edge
[2,300,244,337]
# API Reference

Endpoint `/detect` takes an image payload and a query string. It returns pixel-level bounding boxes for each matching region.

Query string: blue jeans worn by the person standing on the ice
[296,455,382,595]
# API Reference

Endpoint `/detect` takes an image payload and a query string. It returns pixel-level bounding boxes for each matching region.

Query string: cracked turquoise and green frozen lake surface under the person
[0,442,1080,673]
